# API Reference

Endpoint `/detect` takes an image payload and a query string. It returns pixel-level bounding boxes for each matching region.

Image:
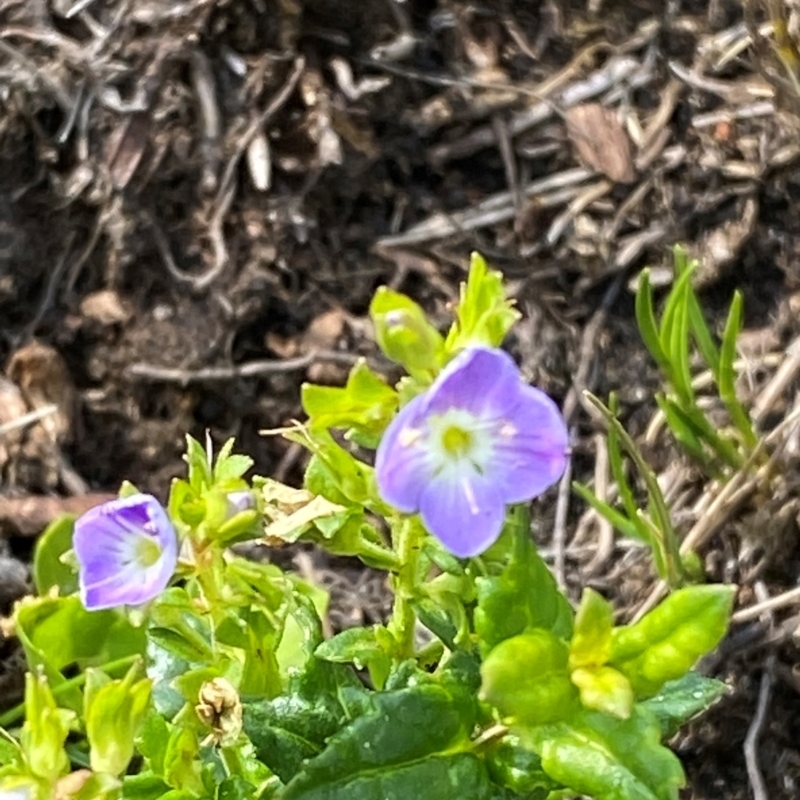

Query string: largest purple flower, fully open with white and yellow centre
[375,347,568,558]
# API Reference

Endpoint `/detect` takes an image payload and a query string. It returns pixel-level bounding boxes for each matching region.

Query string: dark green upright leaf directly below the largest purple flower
[475,506,572,653]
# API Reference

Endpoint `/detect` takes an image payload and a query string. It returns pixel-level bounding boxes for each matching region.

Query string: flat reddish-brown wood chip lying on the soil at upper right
[564,103,636,183]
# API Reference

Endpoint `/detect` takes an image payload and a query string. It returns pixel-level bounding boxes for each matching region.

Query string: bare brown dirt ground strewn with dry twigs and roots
[0,0,800,800]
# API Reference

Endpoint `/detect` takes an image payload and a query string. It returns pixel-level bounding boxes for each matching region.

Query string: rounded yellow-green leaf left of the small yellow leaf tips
[481,630,578,725]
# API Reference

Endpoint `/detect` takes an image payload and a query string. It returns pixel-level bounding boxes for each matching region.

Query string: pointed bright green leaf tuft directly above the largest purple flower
[445,253,520,355]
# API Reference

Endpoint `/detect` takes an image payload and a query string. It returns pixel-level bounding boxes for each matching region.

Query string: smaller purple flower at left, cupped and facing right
[72,494,178,611]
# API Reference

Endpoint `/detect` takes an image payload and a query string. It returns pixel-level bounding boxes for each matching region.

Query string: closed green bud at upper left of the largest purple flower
[369,286,444,380]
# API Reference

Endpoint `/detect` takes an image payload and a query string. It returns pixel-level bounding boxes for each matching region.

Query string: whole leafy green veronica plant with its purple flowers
[0,256,732,800]
